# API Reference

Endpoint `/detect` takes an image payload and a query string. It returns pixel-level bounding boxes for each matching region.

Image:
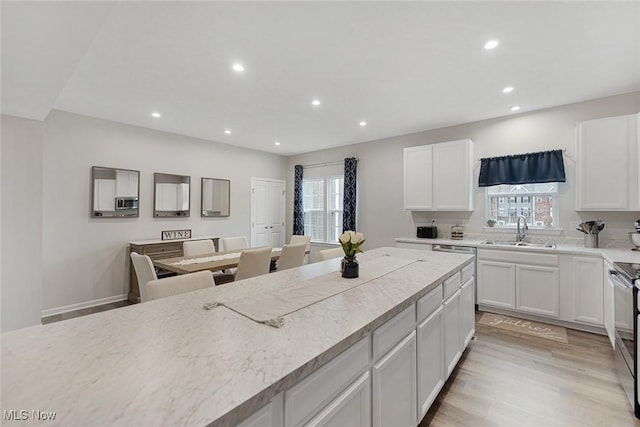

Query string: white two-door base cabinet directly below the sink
[478,249,560,318]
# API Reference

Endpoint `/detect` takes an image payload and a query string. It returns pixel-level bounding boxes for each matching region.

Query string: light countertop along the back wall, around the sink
[395,236,640,263]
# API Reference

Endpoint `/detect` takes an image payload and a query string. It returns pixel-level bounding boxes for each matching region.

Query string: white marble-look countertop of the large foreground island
[0,248,472,426]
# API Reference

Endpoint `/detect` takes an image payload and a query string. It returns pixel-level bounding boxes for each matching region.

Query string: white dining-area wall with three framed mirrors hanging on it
[41,111,286,314]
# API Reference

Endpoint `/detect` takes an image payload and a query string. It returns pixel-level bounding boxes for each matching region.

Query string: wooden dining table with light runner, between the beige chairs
[153,248,309,274]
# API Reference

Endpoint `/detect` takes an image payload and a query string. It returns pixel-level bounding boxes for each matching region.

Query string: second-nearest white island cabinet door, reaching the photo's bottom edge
[372,330,418,427]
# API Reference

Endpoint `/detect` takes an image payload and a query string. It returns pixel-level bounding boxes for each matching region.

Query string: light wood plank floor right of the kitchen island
[419,313,640,427]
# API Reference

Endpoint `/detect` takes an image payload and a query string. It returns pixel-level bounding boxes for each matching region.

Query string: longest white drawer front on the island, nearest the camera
[284,336,369,427]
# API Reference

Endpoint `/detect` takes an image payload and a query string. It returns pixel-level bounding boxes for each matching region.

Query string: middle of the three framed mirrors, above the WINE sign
[153,173,191,218]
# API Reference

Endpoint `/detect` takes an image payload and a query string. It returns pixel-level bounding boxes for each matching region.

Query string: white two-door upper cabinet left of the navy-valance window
[404,139,473,211]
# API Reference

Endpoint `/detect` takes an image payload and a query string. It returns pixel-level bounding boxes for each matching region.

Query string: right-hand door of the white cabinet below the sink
[516,265,560,318]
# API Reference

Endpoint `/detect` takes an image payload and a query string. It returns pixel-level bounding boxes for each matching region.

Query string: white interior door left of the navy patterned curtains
[251,178,285,248]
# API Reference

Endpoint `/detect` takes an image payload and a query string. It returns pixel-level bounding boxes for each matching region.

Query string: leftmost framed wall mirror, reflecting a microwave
[91,166,140,218]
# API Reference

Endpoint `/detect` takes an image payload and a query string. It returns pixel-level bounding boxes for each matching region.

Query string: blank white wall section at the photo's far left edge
[0,115,43,332]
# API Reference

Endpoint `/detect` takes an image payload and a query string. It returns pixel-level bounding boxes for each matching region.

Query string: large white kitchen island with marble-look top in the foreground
[1,248,473,426]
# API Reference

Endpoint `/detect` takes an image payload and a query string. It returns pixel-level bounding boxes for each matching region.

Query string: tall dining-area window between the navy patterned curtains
[302,175,344,243]
